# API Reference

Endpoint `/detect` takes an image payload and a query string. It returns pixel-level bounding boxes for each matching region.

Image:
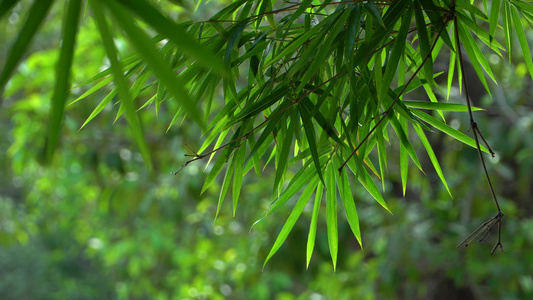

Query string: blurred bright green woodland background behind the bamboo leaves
[0,1,533,300]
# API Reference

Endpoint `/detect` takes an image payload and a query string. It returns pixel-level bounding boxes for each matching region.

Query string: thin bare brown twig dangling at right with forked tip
[452,1,505,255]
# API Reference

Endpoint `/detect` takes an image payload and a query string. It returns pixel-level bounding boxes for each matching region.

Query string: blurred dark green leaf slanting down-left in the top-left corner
[0,0,53,95]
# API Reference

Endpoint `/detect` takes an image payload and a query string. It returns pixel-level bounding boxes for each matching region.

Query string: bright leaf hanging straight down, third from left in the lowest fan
[326,162,339,271]
